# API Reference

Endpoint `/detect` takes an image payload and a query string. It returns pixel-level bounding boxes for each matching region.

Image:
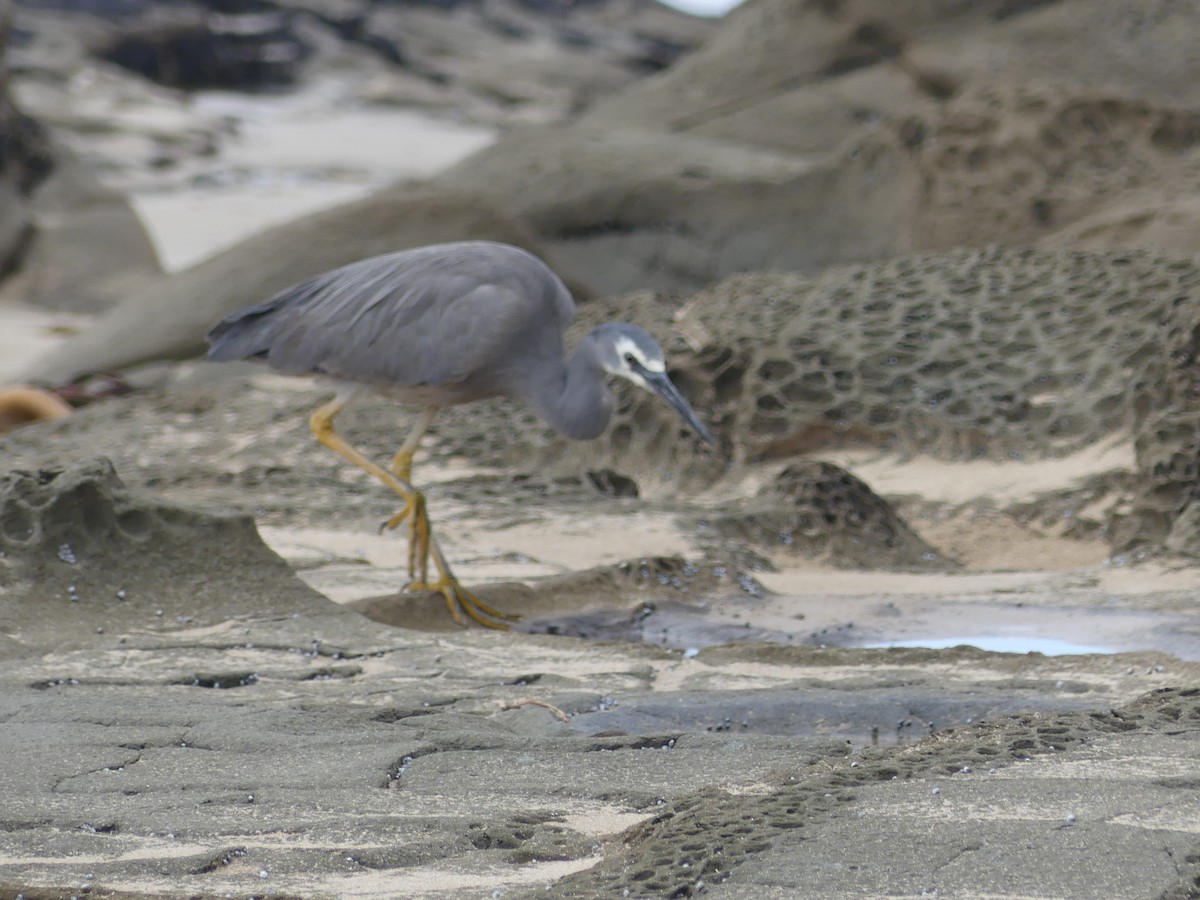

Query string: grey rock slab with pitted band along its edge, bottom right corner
[542,690,1196,899]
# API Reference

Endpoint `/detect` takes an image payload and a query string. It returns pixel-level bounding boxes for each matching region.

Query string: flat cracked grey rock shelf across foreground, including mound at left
[0,462,1200,896]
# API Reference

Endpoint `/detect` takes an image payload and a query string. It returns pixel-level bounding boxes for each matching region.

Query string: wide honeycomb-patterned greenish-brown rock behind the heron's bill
[559,247,1200,553]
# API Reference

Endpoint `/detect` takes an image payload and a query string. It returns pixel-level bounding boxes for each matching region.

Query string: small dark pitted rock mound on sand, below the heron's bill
[708,460,955,569]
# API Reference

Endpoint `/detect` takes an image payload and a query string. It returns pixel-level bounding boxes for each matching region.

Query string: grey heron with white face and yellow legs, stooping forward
[208,241,715,629]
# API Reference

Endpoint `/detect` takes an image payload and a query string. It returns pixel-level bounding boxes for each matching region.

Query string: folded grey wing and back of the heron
[209,241,574,386]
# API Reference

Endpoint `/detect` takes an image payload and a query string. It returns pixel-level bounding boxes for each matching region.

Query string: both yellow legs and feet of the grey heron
[308,398,517,629]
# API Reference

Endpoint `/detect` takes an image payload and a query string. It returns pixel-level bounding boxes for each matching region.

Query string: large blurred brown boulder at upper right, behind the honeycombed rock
[448,0,1200,293]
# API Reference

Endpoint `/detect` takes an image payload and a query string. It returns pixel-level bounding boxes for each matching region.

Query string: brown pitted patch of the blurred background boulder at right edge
[900,84,1200,256]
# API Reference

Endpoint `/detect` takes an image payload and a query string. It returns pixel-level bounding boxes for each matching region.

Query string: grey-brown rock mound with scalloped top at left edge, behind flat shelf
[0,458,334,649]
